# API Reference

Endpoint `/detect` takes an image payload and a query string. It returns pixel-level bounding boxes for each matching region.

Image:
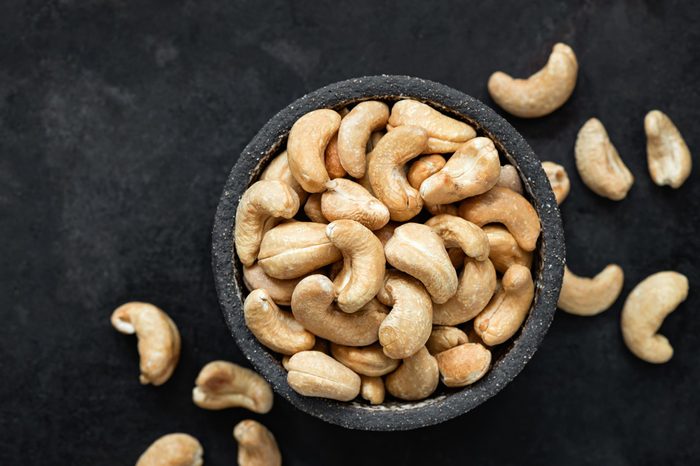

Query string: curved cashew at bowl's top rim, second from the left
[338,100,389,178]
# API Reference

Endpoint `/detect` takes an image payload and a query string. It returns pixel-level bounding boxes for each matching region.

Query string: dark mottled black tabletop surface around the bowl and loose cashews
[0,0,700,465]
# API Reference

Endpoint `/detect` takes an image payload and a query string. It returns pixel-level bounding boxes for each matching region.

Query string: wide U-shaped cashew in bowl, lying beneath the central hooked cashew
[292,275,387,346]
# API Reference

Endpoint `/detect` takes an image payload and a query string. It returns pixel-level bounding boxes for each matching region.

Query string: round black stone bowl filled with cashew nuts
[212,76,565,431]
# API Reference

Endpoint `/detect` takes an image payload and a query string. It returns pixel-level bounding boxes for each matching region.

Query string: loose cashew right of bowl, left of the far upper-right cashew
[574,118,634,201]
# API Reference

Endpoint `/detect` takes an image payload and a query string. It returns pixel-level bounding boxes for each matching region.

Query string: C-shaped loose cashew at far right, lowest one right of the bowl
[620,271,688,364]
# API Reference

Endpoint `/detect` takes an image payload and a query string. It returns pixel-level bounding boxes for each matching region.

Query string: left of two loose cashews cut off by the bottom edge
[136,433,204,466]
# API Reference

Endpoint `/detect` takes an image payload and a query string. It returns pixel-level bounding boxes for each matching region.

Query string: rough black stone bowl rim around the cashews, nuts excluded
[212,76,565,431]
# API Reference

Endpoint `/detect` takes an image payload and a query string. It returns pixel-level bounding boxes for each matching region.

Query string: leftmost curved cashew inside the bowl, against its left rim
[234,180,299,266]
